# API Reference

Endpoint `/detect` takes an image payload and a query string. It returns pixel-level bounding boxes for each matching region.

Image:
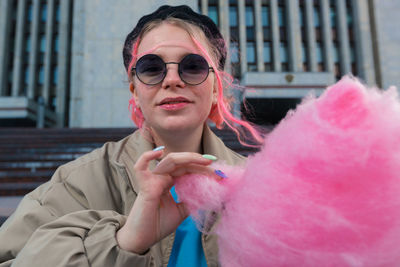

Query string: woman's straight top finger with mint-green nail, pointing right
[153,152,213,174]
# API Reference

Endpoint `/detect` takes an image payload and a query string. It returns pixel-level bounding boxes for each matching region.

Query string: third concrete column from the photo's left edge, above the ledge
[27,0,40,99]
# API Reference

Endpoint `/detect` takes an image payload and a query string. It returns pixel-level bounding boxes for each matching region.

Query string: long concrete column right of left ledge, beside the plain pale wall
[56,0,71,127]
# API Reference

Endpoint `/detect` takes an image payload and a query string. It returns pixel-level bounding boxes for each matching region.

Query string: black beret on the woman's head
[122,5,227,73]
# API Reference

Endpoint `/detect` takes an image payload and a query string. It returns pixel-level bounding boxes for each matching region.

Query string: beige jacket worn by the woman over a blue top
[0,127,244,267]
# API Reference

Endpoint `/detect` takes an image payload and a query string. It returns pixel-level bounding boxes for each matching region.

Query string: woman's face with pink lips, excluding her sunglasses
[131,23,216,136]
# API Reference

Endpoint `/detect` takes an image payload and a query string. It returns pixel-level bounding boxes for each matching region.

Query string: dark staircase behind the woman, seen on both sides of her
[0,128,255,225]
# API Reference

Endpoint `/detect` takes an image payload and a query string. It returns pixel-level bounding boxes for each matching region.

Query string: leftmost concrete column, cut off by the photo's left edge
[0,0,12,96]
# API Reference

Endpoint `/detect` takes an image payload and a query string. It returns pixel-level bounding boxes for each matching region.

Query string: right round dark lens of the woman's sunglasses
[179,54,209,85]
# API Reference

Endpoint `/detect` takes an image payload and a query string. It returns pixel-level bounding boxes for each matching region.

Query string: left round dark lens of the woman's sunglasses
[136,55,165,85]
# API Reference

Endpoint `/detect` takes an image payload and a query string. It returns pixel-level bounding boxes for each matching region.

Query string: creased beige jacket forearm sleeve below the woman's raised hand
[13,210,151,266]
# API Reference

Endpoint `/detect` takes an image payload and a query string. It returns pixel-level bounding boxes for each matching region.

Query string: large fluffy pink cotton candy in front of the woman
[176,77,400,267]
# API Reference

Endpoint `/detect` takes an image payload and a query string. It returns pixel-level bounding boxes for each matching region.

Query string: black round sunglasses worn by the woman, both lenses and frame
[132,54,214,85]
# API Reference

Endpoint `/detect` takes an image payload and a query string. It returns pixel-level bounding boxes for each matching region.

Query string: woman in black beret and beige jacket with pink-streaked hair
[0,6,258,267]
